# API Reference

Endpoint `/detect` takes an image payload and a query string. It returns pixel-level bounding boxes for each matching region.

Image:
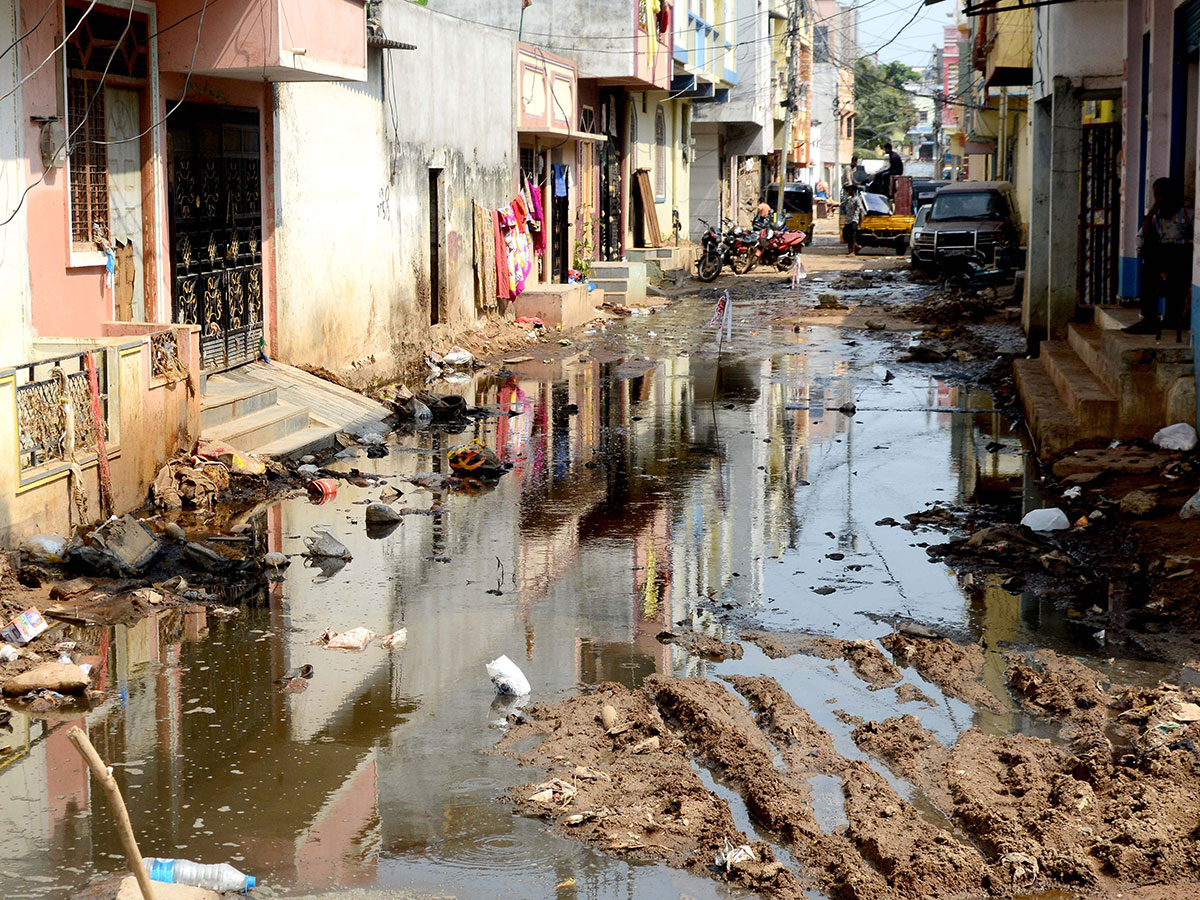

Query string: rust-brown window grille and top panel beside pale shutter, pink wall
[65,6,149,245]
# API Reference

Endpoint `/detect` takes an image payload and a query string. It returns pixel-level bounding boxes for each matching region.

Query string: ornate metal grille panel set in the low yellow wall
[17,350,108,473]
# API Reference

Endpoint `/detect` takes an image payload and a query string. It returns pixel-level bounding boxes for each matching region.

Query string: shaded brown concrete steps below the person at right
[1013,307,1195,457]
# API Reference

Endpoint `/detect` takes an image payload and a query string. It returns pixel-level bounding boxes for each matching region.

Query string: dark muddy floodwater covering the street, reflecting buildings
[0,292,1169,900]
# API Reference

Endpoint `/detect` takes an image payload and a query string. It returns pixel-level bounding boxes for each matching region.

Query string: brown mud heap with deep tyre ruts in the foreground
[500,632,1200,900]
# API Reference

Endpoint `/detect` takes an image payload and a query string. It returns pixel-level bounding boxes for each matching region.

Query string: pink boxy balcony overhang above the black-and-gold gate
[157,0,367,82]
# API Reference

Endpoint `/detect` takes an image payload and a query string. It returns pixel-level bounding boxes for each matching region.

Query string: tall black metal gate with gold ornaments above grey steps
[167,103,263,371]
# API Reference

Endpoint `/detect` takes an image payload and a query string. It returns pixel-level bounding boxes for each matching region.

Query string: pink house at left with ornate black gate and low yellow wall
[0,0,366,539]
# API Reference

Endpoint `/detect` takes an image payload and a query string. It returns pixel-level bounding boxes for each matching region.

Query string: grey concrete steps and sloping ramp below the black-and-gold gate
[200,362,390,457]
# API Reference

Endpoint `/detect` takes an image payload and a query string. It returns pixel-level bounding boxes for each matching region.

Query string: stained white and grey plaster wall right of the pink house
[275,2,516,384]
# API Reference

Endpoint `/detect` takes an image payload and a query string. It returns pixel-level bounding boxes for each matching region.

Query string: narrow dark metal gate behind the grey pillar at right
[1079,125,1121,306]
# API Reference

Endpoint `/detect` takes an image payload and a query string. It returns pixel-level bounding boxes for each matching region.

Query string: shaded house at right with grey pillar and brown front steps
[1016,0,1200,452]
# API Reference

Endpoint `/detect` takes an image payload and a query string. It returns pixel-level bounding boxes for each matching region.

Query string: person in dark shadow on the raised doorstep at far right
[1124,178,1194,337]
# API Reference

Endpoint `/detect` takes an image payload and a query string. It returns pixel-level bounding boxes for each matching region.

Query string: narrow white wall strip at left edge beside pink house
[0,1,31,367]
